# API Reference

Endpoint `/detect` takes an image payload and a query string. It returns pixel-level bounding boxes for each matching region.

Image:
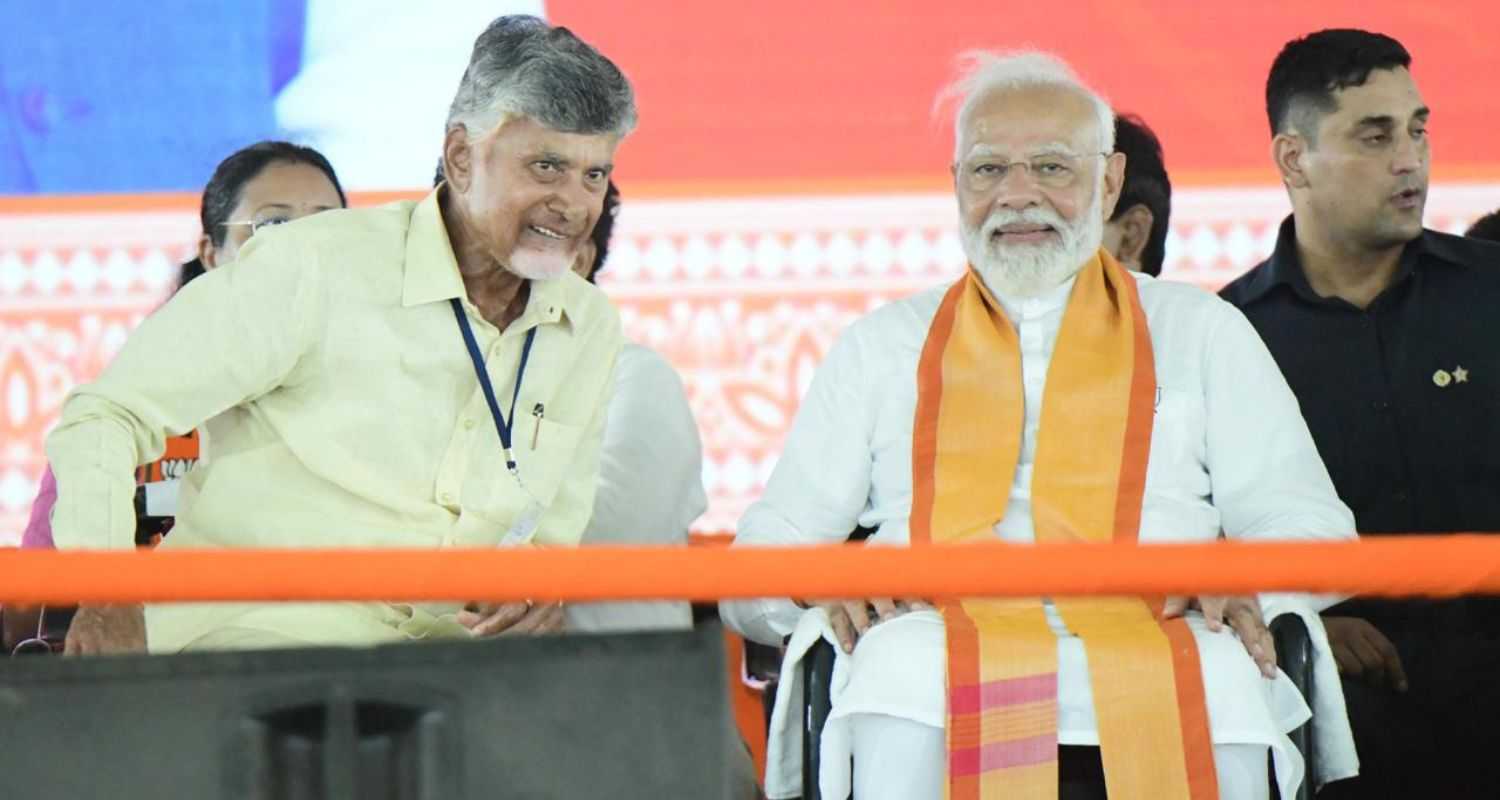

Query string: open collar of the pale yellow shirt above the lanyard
[401,189,581,330]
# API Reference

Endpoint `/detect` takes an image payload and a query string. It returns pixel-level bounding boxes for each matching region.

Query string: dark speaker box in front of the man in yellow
[0,626,738,800]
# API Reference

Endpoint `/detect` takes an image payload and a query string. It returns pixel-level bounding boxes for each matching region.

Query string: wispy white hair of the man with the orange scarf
[936,50,1115,159]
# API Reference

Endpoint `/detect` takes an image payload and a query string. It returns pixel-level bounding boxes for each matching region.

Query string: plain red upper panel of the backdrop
[548,0,1500,191]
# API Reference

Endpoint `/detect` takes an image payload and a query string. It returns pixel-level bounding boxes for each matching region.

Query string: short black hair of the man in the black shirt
[1266,29,1412,140]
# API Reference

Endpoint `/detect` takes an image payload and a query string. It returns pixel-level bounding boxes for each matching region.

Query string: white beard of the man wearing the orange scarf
[963,186,1104,297]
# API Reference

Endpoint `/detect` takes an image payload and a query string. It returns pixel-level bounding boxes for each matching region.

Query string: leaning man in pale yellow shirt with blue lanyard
[47,17,636,653]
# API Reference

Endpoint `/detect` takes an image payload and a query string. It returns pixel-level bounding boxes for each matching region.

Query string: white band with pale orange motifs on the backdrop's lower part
[0,185,1500,543]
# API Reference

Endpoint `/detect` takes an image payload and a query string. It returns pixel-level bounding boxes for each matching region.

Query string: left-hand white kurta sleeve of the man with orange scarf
[719,324,879,645]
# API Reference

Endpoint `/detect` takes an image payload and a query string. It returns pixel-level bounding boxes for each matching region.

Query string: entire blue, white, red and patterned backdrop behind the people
[0,0,1500,545]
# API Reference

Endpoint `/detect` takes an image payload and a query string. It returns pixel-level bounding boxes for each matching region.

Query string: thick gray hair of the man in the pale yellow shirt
[447,15,636,137]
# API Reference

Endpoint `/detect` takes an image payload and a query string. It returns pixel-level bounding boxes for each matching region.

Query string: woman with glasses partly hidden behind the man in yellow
[5,141,348,650]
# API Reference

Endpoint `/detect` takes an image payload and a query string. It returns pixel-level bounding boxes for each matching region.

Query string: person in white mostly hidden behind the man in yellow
[564,182,708,633]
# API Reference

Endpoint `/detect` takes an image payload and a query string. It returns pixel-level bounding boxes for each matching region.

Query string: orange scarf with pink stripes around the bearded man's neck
[912,251,1218,800]
